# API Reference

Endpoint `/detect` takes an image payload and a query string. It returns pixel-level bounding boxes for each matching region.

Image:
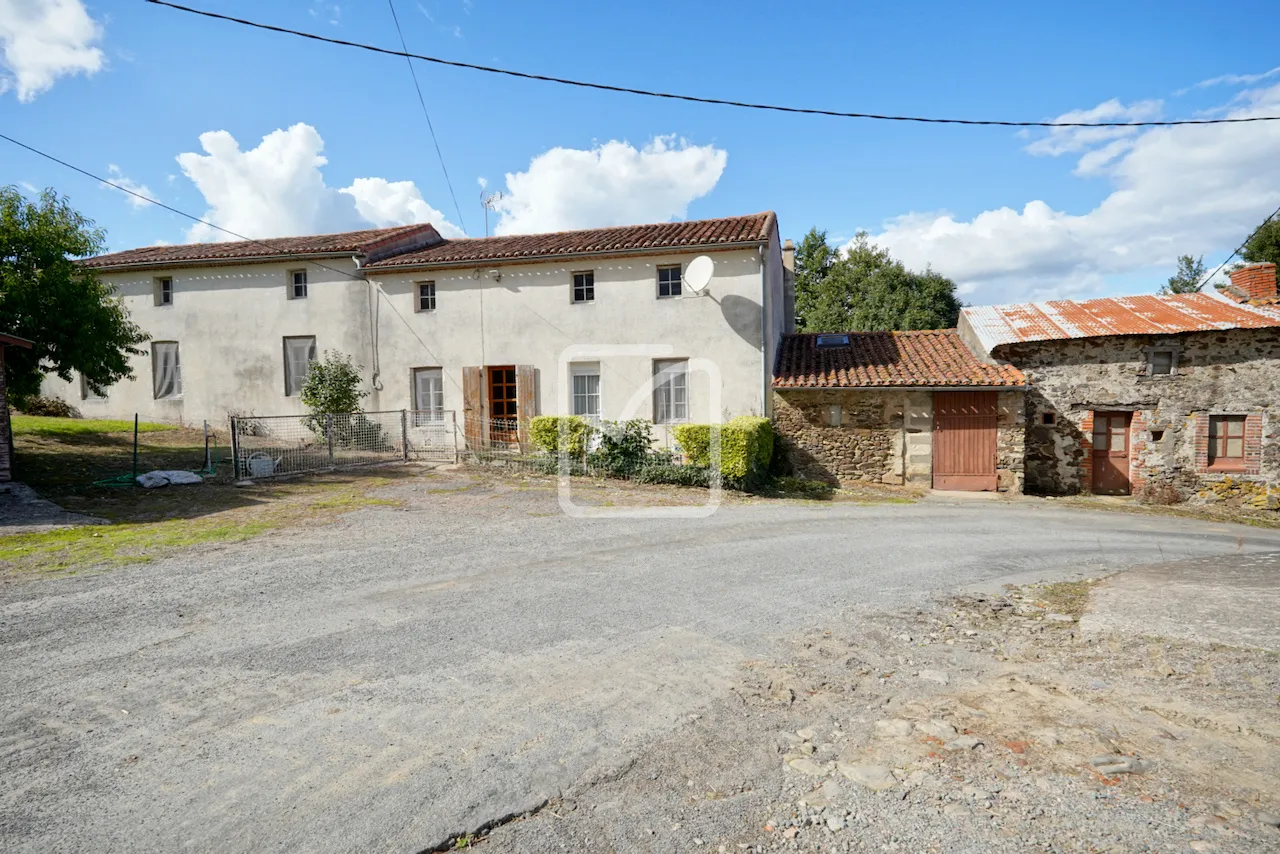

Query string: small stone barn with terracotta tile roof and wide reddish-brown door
[773,329,1024,493]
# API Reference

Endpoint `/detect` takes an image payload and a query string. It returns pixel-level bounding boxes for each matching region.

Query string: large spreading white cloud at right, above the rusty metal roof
[873,85,1280,302]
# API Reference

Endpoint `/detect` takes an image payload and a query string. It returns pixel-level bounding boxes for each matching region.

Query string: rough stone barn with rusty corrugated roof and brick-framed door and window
[959,264,1280,506]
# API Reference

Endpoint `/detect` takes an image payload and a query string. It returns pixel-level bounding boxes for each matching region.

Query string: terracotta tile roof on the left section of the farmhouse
[81,224,439,270]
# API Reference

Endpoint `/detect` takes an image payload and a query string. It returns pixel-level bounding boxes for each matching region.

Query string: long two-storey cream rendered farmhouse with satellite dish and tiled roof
[45,213,794,448]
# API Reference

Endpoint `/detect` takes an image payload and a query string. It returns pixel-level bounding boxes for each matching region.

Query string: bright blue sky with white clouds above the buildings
[0,0,1280,302]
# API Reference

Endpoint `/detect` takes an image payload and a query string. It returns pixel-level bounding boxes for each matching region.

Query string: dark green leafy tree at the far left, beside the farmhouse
[0,187,147,401]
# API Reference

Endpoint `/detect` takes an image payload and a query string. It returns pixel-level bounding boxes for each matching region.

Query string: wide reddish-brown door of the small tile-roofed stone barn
[933,392,1000,492]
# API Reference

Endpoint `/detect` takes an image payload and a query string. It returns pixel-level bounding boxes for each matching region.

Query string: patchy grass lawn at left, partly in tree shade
[0,416,413,572]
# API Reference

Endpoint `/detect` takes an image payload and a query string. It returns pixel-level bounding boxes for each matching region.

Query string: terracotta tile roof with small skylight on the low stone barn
[773,329,1027,388]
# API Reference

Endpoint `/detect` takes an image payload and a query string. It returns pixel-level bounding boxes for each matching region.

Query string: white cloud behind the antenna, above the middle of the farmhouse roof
[494,137,728,234]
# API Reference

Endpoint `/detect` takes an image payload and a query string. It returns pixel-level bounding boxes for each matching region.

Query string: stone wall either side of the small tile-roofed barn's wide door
[773,388,1025,493]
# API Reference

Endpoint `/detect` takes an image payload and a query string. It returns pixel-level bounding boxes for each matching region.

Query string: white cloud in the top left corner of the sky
[0,0,104,104]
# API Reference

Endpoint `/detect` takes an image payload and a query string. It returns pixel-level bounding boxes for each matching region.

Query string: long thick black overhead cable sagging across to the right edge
[147,0,1280,128]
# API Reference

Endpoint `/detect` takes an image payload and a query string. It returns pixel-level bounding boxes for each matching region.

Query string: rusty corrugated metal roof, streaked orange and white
[964,293,1280,352]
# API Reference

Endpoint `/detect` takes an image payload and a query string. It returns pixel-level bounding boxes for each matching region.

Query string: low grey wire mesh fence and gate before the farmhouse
[230,410,457,479]
